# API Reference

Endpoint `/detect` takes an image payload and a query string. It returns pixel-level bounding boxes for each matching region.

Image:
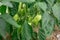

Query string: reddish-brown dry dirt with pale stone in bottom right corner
[46,25,60,40]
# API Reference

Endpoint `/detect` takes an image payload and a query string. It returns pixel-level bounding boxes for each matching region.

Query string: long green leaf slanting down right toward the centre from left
[2,14,20,28]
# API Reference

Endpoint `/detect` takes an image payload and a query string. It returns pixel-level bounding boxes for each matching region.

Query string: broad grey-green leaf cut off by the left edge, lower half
[0,17,7,38]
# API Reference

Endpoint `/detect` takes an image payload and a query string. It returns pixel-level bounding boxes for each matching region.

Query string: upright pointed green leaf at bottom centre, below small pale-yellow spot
[21,21,32,40]
